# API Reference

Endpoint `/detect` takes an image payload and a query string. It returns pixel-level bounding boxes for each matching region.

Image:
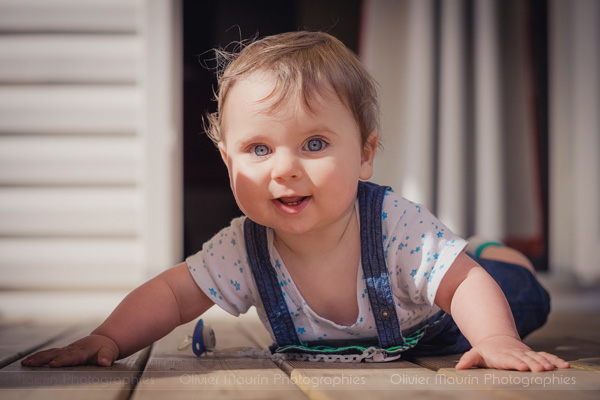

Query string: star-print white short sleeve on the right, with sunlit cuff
[382,192,467,309]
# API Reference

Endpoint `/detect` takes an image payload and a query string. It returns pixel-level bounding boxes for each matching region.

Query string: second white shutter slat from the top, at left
[0,34,141,84]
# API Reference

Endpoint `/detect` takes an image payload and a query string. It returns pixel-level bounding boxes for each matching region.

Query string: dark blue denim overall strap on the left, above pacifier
[244,218,301,347]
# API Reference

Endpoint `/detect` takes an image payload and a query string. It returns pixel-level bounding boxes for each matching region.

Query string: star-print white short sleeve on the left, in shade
[186,217,256,316]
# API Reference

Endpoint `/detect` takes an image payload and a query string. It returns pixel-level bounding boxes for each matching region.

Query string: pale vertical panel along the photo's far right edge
[550,0,600,284]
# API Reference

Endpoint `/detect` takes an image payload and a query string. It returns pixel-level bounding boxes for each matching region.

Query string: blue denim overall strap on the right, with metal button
[358,181,404,349]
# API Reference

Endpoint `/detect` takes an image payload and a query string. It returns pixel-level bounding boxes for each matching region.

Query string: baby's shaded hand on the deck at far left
[21,334,119,367]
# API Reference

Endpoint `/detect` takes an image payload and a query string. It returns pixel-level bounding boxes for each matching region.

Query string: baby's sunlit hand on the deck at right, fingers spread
[456,336,569,372]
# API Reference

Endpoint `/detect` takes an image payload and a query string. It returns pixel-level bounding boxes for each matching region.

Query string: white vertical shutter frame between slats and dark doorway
[141,0,183,275]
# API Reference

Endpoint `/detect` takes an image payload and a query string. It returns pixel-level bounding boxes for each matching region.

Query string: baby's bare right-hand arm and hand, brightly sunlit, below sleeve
[435,253,569,371]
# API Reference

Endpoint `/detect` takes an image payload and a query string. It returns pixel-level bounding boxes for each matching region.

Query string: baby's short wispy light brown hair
[205,31,379,146]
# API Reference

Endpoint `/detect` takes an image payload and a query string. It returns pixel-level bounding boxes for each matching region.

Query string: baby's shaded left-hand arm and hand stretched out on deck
[22,263,214,367]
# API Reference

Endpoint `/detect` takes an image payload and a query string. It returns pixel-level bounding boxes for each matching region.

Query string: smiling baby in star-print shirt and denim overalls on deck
[22,32,569,371]
